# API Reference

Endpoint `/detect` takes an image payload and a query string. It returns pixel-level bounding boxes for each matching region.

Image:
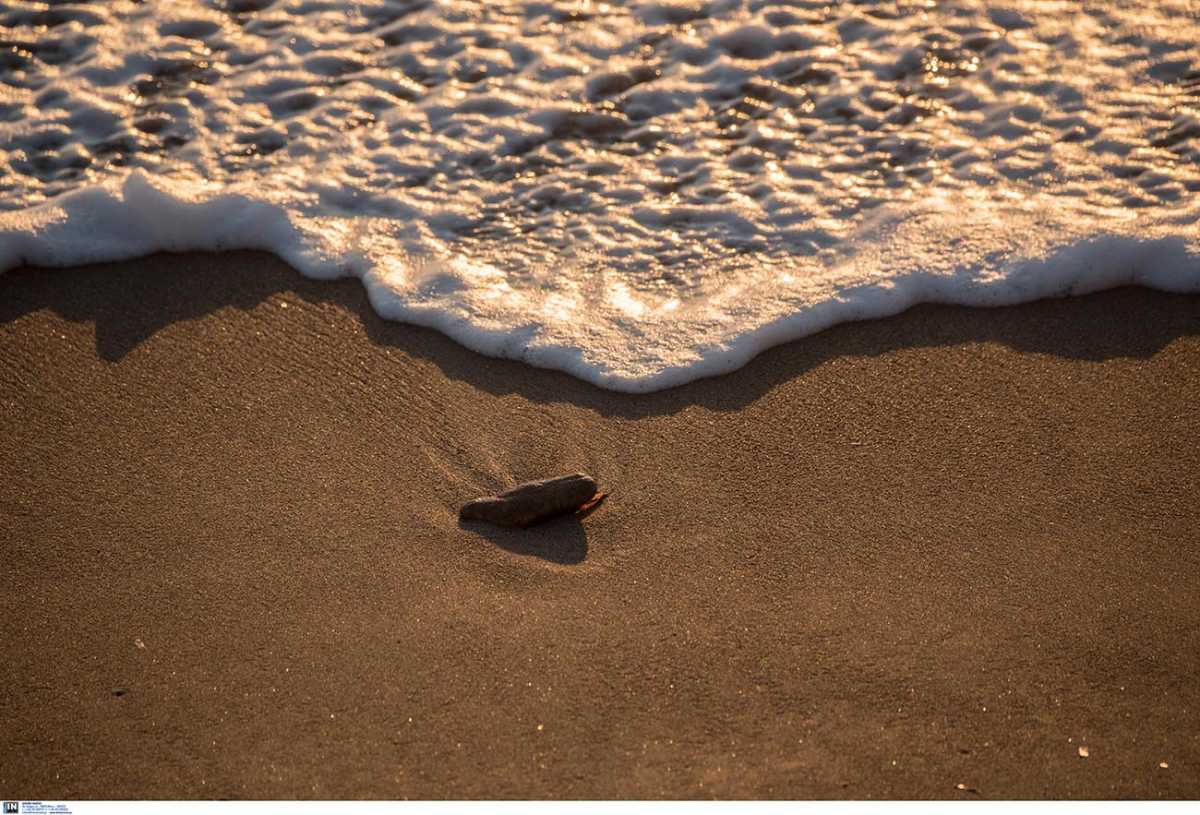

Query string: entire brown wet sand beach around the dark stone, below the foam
[0,253,1200,798]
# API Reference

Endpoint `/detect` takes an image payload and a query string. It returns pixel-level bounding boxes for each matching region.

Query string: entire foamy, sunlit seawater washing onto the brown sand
[0,0,1200,390]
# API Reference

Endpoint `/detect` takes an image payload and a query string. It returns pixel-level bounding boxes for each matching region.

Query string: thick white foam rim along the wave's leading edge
[0,170,1200,394]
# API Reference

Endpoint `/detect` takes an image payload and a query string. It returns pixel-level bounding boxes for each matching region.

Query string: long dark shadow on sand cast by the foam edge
[0,251,1200,419]
